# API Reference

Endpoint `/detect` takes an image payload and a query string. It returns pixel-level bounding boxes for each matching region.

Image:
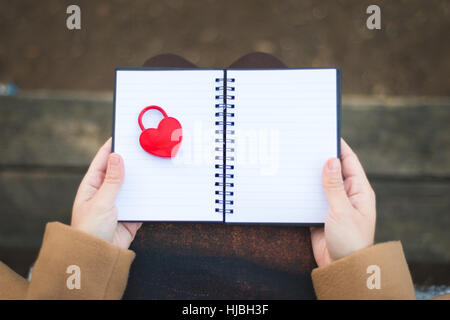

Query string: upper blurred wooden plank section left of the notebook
[0,97,112,167]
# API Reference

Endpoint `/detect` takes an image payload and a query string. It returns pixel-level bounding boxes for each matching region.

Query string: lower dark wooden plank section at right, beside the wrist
[372,179,450,264]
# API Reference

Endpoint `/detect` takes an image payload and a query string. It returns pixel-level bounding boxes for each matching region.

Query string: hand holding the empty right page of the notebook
[311,139,376,267]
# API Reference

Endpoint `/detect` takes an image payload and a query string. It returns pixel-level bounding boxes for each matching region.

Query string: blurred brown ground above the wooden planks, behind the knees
[0,0,450,96]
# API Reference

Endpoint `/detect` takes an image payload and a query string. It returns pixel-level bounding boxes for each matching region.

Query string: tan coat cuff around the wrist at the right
[312,241,415,300]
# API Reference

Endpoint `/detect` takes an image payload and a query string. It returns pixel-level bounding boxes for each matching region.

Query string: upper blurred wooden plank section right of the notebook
[342,105,450,177]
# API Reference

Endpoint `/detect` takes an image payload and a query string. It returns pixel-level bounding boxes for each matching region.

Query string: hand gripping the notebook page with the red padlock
[71,138,142,249]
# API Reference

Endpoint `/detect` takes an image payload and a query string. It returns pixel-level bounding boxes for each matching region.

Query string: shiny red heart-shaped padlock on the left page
[138,106,183,158]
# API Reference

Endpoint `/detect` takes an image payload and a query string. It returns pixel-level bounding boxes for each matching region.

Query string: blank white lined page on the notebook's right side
[226,69,338,223]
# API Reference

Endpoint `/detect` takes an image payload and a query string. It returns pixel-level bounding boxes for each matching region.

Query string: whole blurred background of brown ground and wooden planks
[0,0,450,298]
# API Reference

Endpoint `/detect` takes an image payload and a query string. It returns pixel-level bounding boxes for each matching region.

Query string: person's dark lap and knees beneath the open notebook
[124,53,315,299]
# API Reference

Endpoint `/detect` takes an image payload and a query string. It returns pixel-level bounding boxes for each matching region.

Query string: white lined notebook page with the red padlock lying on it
[114,69,223,221]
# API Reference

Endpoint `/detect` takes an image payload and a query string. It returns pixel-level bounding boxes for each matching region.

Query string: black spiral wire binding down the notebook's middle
[214,71,236,220]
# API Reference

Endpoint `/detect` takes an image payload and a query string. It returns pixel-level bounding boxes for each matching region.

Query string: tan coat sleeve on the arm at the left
[0,222,135,299]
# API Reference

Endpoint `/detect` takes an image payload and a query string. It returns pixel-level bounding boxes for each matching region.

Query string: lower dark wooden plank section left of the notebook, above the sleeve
[0,171,77,248]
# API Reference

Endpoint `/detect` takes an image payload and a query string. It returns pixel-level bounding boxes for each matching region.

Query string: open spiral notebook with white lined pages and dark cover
[113,68,340,224]
